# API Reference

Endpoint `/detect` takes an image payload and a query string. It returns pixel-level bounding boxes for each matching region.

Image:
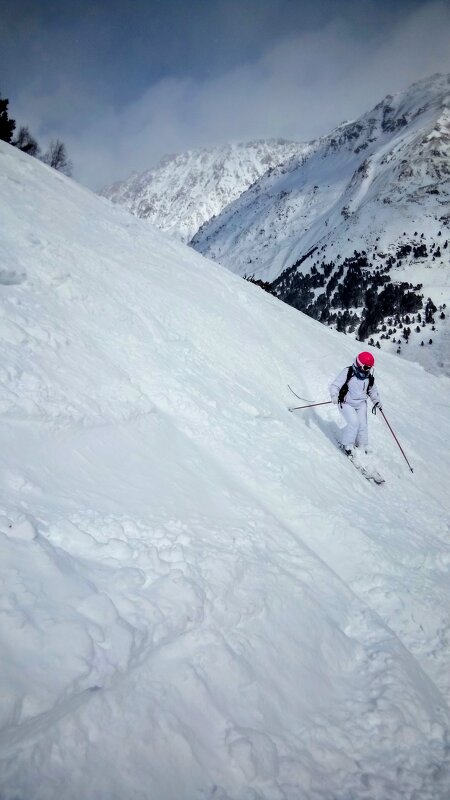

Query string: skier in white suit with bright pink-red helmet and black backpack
[330,352,382,456]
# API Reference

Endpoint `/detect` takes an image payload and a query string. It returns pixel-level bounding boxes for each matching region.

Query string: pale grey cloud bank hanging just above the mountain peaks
[12,2,450,188]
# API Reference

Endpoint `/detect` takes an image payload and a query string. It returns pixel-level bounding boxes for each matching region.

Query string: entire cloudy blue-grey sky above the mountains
[0,0,450,188]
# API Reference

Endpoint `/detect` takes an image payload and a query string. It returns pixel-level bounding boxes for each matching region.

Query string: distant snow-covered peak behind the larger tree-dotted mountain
[100,139,307,242]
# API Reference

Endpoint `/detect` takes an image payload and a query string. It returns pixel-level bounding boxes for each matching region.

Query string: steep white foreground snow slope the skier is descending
[0,142,450,800]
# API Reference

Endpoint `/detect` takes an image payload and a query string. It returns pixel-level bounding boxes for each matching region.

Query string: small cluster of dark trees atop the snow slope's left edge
[0,94,72,175]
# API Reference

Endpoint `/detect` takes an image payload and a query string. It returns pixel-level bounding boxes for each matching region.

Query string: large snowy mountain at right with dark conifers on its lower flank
[192,75,450,374]
